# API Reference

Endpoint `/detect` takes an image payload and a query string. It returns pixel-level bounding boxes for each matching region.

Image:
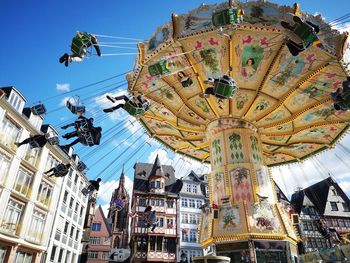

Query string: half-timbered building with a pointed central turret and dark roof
[130,156,182,262]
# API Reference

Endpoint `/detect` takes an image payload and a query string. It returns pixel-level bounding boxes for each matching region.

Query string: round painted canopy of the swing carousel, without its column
[127,2,350,166]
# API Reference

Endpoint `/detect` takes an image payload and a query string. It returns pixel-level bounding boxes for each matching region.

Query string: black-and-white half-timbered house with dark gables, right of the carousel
[291,177,350,253]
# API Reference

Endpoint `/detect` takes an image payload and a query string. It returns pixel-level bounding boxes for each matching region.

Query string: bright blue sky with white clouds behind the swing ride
[0,0,350,210]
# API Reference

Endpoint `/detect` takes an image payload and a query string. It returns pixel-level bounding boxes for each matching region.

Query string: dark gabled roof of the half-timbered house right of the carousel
[291,177,350,217]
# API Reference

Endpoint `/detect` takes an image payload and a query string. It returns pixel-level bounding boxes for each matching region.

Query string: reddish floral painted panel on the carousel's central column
[229,167,253,203]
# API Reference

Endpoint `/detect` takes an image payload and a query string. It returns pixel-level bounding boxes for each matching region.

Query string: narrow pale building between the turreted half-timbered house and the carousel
[178,171,209,262]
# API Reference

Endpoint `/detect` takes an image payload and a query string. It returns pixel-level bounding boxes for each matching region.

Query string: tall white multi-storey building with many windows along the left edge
[0,87,87,263]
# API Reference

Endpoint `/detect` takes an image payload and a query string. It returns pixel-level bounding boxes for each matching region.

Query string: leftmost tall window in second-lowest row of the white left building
[0,199,24,234]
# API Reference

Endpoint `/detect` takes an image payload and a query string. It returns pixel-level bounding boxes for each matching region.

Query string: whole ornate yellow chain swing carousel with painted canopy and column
[123,1,350,262]
